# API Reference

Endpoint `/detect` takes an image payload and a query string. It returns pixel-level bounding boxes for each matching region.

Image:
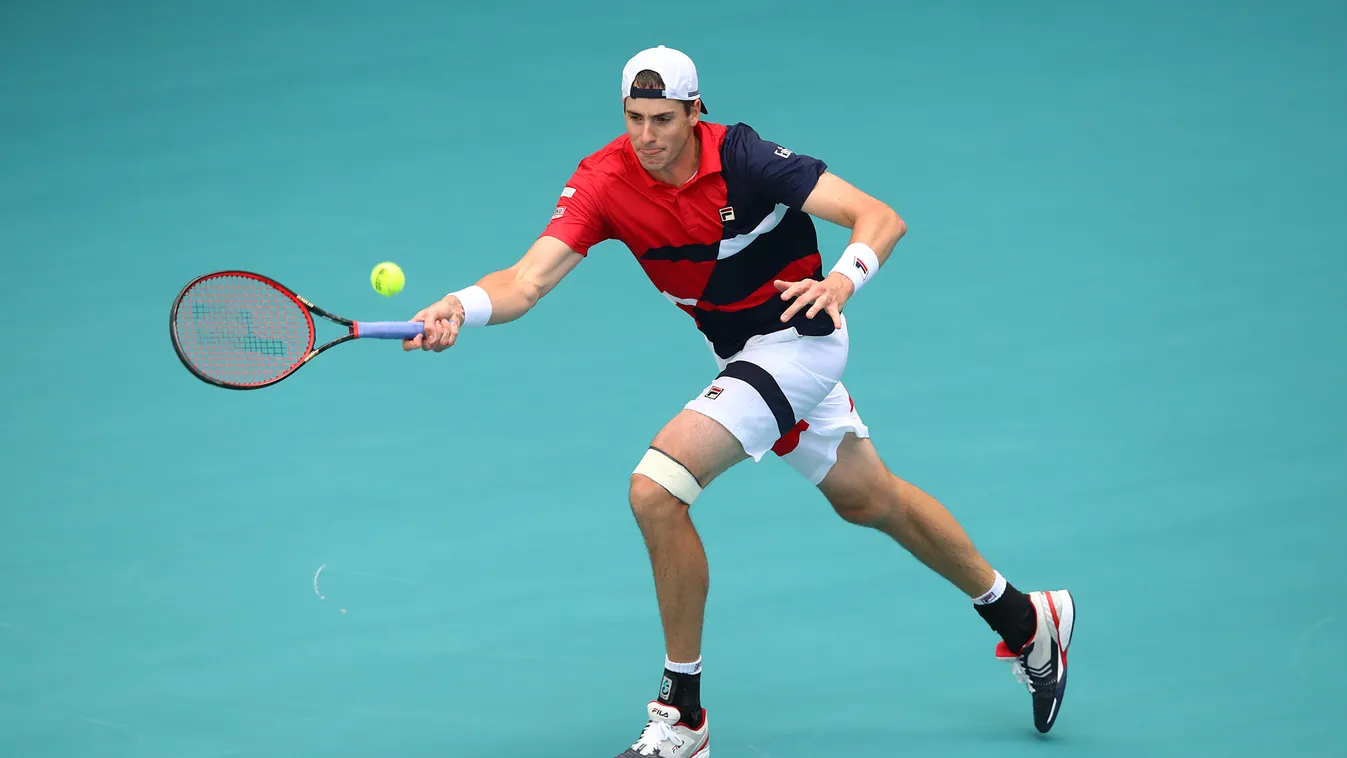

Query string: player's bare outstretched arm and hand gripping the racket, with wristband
[403,236,585,353]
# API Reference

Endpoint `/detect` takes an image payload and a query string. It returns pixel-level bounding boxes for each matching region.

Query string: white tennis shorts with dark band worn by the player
[684,314,870,485]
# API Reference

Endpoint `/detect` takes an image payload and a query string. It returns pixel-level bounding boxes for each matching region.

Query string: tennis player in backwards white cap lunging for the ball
[403,46,1075,758]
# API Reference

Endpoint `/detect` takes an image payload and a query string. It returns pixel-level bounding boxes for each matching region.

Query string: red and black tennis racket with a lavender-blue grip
[168,271,423,389]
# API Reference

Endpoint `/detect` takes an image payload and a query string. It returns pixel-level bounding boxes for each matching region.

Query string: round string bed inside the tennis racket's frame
[174,275,314,385]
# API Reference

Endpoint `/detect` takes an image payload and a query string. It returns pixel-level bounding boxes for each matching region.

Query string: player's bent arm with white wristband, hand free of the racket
[776,171,908,329]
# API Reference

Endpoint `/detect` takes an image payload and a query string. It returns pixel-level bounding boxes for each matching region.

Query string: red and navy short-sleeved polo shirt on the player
[543,121,834,358]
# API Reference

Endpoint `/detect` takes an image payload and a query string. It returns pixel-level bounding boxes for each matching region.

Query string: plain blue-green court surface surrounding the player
[0,0,1347,758]
